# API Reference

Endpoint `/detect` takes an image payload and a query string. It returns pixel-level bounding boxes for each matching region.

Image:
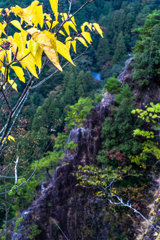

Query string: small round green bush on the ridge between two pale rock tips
[105,77,122,94]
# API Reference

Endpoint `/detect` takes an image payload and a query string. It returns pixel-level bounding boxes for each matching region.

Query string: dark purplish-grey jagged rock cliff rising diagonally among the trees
[12,59,160,240]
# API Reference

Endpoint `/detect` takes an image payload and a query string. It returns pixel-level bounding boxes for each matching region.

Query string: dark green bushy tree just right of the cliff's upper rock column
[98,85,142,166]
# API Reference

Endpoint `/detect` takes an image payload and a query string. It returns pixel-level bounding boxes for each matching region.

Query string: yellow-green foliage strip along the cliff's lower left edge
[9,151,64,211]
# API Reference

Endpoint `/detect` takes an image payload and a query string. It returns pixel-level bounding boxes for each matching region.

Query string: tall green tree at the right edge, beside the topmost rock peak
[133,10,160,86]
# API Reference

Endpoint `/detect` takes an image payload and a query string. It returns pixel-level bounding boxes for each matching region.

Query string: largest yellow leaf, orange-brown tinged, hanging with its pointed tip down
[32,30,62,71]
